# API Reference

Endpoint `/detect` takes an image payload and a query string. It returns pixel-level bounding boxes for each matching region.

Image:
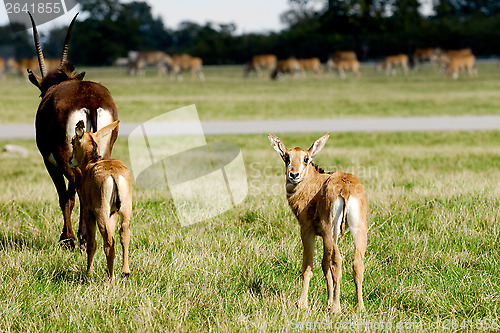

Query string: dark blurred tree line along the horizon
[0,0,500,65]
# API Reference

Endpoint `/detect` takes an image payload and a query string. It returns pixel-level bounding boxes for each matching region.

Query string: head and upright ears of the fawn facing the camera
[268,133,330,185]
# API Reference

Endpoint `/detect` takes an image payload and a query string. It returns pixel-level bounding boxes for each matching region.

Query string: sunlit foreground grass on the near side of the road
[0,132,500,332]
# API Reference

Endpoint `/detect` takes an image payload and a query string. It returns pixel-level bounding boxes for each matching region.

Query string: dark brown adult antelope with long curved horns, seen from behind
[28,14,118,249]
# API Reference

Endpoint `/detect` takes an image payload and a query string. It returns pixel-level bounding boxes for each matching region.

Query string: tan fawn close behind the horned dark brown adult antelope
[69,120,132,281]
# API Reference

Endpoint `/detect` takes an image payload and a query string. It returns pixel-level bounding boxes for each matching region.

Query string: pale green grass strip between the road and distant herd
[0,63,500,123]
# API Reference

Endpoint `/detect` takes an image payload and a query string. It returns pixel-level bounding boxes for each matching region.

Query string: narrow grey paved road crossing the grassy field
[0,116,500,140]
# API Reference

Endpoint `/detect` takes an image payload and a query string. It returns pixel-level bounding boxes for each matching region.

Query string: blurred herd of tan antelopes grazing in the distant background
[0,48,477,81]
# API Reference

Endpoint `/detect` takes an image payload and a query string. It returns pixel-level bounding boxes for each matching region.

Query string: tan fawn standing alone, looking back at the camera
[268,133,368,313]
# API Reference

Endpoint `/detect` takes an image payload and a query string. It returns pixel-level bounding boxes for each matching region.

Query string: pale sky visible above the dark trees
[0,0,290,34]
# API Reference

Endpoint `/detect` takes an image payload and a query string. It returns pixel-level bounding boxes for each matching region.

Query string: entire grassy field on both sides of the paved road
[0,65,500,332]
